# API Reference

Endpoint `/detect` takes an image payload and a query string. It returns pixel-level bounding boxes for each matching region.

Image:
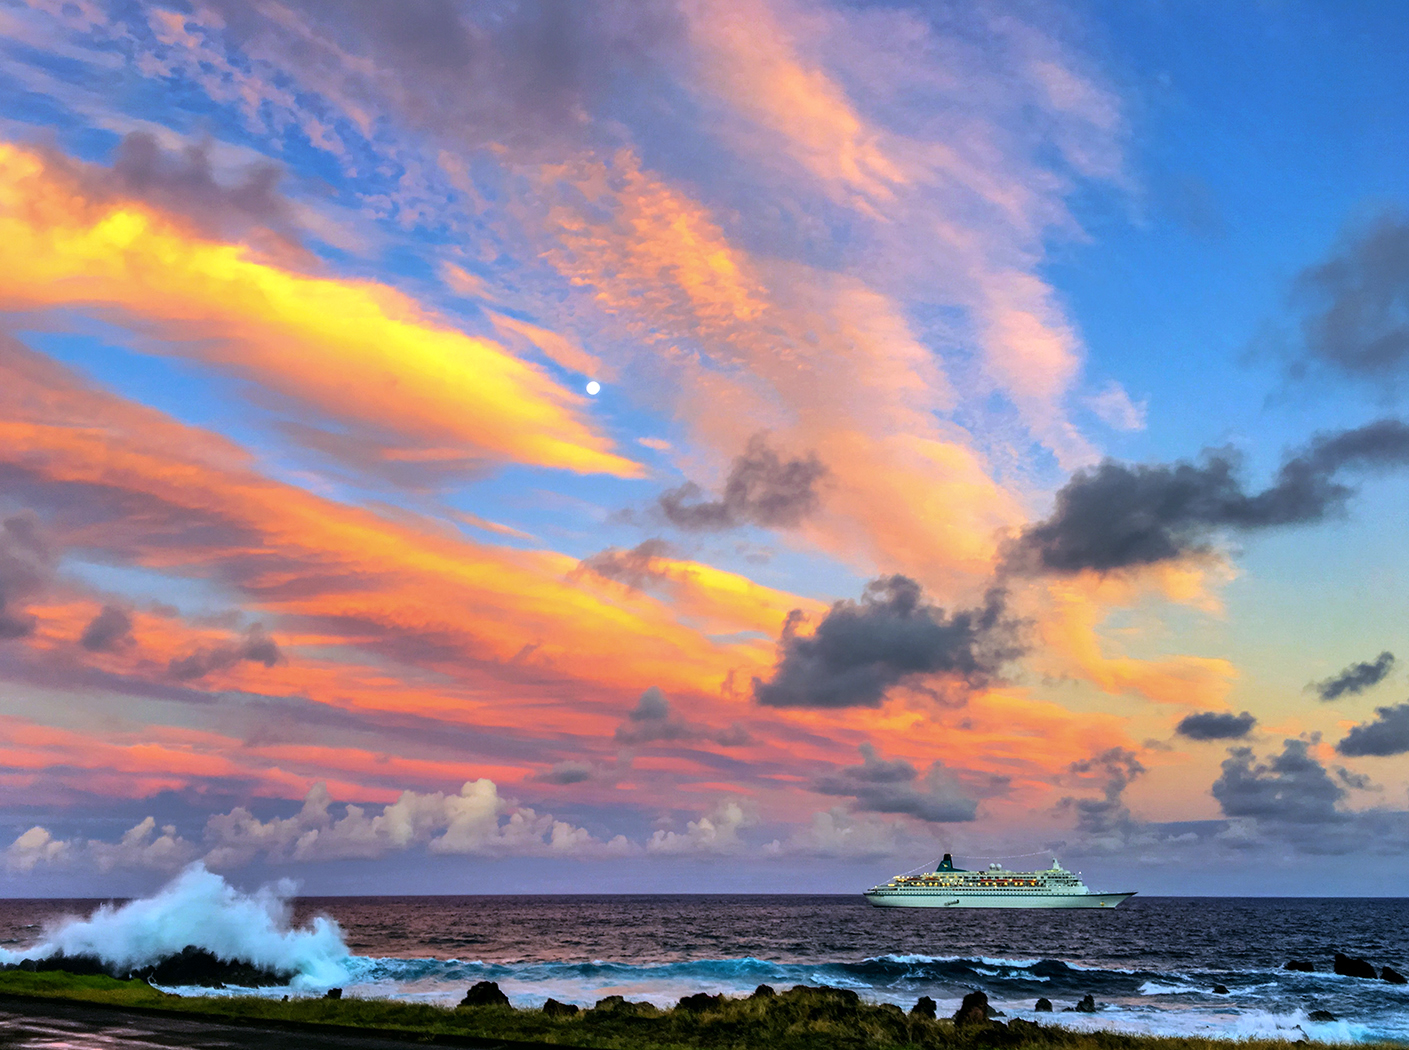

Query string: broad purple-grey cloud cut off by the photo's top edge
[213,0,683,159]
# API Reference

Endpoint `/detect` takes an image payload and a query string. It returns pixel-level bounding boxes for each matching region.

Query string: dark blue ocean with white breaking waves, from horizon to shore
[0,875,1409,1044]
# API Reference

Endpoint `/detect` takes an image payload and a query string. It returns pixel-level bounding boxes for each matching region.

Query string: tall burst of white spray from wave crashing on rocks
[0,861,349,987]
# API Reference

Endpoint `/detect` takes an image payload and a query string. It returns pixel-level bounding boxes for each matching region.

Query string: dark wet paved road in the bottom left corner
[0,998,564,1050]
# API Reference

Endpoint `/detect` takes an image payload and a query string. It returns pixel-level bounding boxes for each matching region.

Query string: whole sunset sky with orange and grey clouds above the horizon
[0,0,1409,896]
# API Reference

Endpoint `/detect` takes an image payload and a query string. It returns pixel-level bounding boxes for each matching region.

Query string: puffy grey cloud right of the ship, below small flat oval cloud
[1212,740,1346,824]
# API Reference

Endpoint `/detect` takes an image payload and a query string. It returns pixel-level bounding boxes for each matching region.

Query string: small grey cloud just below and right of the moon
[658,434,827,531]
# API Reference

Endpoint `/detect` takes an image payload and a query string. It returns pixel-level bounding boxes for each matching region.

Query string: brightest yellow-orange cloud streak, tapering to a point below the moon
[0,144,641,478]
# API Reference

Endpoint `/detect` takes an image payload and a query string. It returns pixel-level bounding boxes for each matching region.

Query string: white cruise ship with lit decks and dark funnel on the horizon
[865,853,1134,908]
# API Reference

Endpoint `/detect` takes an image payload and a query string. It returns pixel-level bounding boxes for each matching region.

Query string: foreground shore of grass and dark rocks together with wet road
[0,971,1405,1050]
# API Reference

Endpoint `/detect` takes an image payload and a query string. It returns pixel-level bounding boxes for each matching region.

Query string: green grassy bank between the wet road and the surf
[0,970,1386,1050]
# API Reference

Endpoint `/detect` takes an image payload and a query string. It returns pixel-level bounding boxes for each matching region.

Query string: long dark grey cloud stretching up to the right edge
[1005,419,1409,574]
